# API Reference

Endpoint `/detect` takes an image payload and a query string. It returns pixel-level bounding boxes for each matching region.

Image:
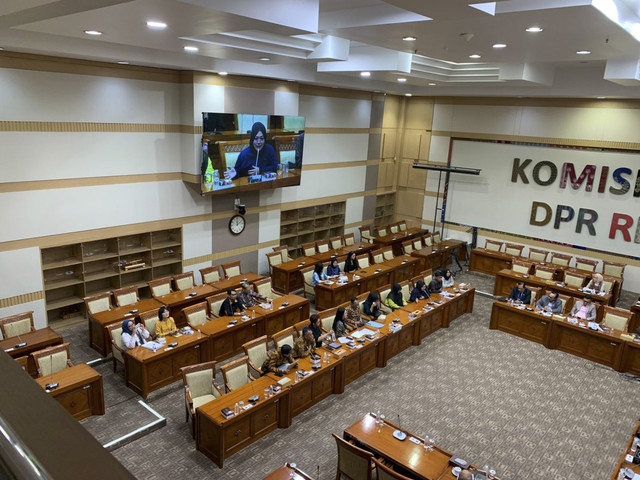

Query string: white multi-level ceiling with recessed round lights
[0,0,640,98]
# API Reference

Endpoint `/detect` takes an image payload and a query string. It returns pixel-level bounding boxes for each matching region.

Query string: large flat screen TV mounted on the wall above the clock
[201,113,305,195]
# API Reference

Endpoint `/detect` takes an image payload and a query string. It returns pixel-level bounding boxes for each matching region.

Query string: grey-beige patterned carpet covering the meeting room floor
[55,273,640,480]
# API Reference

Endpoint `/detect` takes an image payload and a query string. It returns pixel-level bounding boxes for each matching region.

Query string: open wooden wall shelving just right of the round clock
[280,202,346,257]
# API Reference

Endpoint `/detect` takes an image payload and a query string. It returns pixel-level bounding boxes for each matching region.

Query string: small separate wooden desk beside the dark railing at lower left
[36,363,105,420]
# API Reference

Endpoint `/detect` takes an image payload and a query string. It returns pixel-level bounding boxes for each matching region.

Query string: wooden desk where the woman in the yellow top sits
[124,333,211,398]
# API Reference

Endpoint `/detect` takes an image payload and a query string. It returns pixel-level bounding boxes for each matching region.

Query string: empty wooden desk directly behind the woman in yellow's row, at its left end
[88,298,162,357]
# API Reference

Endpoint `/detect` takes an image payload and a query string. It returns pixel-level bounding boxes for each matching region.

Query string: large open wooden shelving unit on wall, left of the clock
[41,228,182,323]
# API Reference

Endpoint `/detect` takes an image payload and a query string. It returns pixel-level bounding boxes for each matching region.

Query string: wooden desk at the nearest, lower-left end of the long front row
[196,376,290,468]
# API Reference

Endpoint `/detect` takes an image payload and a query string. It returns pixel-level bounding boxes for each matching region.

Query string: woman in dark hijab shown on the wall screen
[224,122,278,179]
